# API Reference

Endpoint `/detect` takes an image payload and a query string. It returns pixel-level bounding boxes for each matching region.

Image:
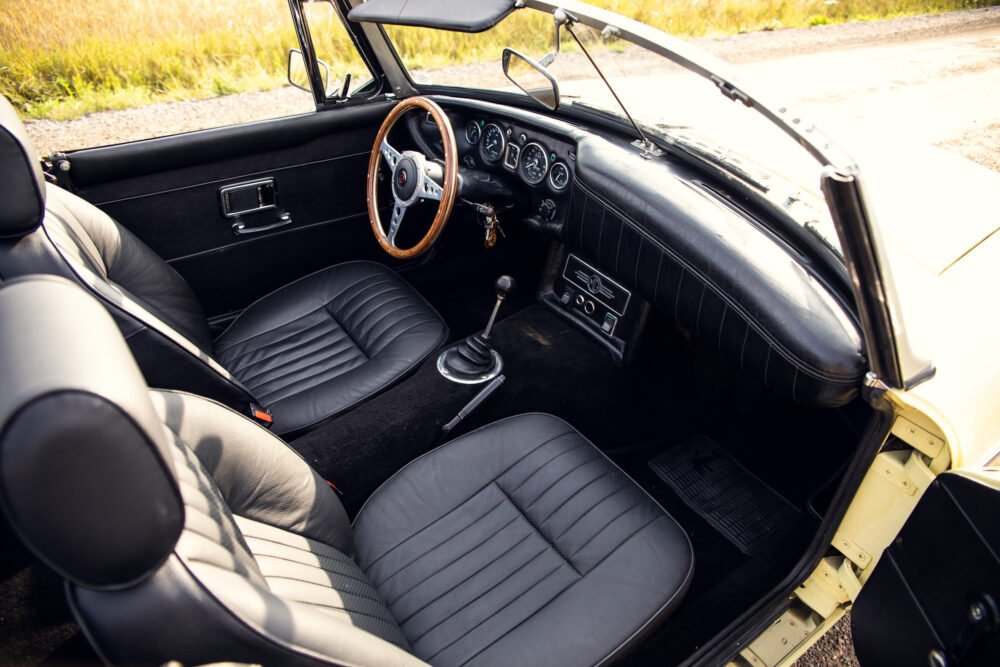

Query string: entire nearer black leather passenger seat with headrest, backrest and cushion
[0,277,693,665]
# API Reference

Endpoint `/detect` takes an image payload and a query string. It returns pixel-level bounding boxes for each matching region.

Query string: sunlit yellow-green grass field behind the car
[0,0,1000,119]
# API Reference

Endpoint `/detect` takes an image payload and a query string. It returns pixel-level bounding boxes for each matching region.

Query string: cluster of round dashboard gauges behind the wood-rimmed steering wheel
[459,118,576,195]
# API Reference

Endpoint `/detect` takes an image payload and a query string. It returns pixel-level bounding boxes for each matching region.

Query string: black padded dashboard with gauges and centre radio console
[418,98,867,407]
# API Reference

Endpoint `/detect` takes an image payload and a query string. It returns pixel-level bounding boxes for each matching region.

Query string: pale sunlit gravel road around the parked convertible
[19,7,1000,667]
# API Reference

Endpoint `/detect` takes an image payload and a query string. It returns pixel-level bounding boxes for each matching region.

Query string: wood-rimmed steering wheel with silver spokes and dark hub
[365,97,458,259]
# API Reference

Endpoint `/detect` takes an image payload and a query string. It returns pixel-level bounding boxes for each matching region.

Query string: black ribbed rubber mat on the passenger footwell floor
[649,435,799,556]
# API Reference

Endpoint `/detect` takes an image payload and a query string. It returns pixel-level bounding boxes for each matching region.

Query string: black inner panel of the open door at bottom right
[851,471,1000,667]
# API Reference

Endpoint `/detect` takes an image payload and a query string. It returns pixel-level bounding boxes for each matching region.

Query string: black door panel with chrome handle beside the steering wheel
[59,103,391,318]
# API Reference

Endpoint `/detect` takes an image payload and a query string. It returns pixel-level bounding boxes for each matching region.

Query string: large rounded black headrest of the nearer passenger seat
[0,276,184,588]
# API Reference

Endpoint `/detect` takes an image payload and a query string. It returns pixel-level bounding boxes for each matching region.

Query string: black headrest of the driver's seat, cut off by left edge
[0,95,45,238]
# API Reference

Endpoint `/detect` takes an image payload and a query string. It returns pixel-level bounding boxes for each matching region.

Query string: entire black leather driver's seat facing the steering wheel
[0,98,447,436]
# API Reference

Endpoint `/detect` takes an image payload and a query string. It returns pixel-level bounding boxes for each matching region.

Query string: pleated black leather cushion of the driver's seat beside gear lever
[215,261,448,434]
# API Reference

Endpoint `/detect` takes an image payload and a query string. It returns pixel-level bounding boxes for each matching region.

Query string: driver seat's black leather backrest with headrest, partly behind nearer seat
[0,97,253,409]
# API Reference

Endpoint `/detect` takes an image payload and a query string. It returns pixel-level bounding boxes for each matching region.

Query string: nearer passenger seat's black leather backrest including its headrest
[0,277,422,665]
